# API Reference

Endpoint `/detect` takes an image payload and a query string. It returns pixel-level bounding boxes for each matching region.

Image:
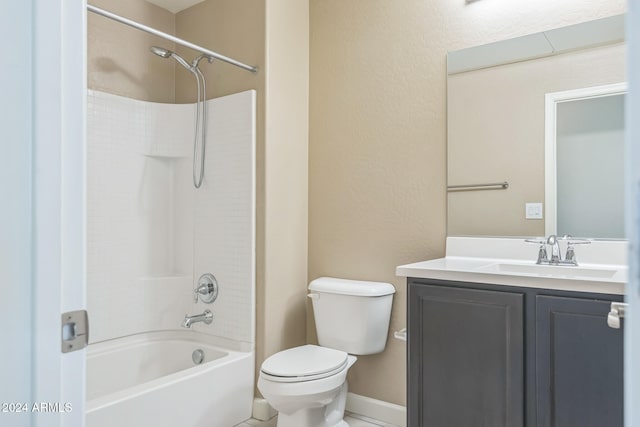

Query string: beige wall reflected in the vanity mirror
[447,44,626,236]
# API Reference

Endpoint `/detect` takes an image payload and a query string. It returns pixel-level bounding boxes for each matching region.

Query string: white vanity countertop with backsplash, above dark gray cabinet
[396,237,628,295]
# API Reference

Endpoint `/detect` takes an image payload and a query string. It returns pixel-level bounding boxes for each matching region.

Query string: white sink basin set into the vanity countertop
[477,263,618,279]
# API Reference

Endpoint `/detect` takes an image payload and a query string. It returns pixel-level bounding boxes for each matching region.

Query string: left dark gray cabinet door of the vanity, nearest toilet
[407,284,524,427]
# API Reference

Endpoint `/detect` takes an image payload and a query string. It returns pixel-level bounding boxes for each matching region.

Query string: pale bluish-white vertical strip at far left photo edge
[0,2,33,427]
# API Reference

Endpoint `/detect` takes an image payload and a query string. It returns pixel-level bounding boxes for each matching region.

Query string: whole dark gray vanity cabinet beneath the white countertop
[407,278,623,427]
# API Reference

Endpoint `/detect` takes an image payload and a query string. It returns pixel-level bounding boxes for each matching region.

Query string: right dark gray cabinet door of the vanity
[536,296,623,427]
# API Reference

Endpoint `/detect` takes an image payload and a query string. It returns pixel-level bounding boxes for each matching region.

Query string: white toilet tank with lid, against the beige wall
[309,277,396,355]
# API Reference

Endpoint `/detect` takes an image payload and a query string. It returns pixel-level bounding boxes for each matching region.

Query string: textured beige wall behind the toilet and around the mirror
[308,0,624,404]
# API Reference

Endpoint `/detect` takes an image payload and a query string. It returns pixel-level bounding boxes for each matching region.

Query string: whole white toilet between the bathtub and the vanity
[258,277,395,427]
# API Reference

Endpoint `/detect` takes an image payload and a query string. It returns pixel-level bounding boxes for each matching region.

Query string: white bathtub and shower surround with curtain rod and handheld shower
[86,6,256,427]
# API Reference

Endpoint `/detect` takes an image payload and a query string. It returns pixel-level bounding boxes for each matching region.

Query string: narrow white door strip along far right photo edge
[625,4,640,426]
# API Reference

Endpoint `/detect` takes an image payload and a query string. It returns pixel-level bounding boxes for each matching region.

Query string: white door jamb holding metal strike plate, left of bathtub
[32,0,87,427]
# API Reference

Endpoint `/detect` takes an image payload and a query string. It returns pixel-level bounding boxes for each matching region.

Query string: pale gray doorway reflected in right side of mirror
[545,85,625,239]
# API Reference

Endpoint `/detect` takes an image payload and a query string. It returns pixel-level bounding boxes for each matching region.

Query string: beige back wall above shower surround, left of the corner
[87,0,175,102]
